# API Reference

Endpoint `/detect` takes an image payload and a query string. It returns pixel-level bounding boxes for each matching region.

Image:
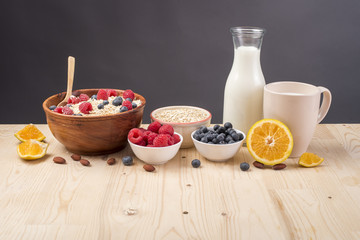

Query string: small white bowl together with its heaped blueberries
[191,122,246,162]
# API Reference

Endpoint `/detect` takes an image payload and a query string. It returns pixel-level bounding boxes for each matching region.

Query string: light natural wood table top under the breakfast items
[0,124,360,240]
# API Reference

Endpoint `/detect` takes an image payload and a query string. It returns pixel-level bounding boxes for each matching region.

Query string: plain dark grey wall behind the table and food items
[0,0,360,123]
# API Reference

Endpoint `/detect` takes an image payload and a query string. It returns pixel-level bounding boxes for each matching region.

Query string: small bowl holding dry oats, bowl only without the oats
[150,106,211,148]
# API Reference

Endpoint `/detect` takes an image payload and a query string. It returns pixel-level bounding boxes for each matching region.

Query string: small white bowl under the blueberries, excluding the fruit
[191,128,246,162]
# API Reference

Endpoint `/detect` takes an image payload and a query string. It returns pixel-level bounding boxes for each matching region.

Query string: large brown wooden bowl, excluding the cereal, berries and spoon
[43,89,146,155]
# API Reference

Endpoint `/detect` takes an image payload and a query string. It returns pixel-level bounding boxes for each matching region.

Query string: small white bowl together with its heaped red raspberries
[128,121,183,165]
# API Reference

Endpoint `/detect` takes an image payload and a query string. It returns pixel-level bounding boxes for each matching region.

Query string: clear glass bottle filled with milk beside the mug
[223,27,265,134]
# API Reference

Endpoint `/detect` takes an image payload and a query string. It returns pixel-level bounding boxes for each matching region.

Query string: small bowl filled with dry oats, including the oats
[150,106,212,148]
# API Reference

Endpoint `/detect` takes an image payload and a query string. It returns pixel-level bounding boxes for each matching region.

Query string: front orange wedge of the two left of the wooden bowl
[17,139,49,160]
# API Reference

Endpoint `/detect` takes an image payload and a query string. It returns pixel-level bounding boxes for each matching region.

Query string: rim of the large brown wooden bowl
[42,88,146,120]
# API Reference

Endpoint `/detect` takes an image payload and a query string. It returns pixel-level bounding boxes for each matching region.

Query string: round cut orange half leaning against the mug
[246,119,294,165]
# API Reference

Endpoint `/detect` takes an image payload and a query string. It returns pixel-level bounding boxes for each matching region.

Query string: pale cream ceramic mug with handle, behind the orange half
[263,82,331,157]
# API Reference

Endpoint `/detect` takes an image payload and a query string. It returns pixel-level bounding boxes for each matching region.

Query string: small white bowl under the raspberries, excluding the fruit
[128,132,183,165]
